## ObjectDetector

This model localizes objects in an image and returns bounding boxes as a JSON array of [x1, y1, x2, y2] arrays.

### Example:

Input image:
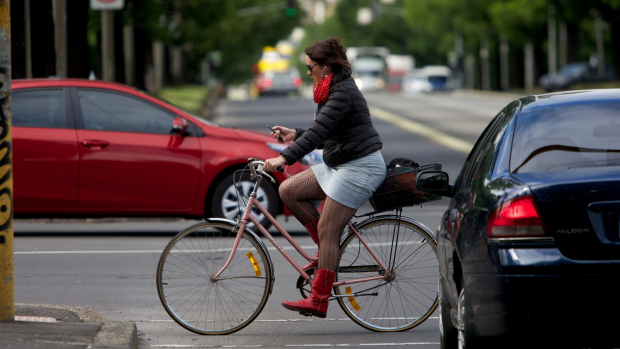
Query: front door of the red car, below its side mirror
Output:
[[72, 88, 201, 214]]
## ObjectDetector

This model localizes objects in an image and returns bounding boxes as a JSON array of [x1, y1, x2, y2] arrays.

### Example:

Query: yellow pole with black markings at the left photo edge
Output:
[[0, 0, 15, 321]]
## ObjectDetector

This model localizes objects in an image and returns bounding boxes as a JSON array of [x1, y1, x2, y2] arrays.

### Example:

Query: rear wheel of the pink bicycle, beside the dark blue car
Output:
[[334, 218, 439, 332]]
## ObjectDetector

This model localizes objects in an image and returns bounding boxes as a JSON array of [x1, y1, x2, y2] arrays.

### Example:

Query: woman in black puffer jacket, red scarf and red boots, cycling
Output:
[[264, 38, 386, 317]]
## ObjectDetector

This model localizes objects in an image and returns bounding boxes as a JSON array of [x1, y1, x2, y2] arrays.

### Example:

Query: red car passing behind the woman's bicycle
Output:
[[11, 79, 322, 228]]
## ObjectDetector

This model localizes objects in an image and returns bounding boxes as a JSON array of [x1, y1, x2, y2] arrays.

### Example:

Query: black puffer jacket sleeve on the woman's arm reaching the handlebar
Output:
[[280, 89, 351, 165]]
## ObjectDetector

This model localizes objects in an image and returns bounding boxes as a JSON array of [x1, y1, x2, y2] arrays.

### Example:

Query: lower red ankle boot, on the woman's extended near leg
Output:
[[282, 269, 336, 318]]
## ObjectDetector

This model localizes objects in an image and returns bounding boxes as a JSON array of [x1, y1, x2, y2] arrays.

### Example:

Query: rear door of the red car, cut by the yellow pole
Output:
[[11, 87, 79, 214]]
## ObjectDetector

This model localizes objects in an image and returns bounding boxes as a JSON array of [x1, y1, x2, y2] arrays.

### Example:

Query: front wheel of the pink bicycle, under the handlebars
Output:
[[157, 222, 272, 335]]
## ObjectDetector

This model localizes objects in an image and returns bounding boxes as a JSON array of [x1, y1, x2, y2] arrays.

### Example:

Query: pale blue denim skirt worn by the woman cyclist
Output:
[[311, 150, 386, 209]]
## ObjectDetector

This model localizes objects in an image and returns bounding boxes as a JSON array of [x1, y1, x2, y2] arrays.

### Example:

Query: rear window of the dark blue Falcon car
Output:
[[510, 103, 620, 173]]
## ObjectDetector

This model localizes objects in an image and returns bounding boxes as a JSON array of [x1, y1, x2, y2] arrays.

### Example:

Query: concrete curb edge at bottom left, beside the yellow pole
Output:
[[15, 303, 138, 349]]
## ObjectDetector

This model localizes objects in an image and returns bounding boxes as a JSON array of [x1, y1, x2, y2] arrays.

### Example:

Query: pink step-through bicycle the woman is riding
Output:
[[157, 159, 439, 335]]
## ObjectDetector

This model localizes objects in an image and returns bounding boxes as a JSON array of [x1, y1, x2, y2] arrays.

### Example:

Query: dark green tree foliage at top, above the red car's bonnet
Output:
[[125, 0, 302, 82]]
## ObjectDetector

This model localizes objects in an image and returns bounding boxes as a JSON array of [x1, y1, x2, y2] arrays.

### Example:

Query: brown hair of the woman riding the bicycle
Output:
[[305, 37, 351, 84]]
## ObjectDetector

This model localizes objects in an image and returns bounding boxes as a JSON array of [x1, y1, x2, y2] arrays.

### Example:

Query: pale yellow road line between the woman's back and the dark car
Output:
[[368, 107, 474, 154]]
